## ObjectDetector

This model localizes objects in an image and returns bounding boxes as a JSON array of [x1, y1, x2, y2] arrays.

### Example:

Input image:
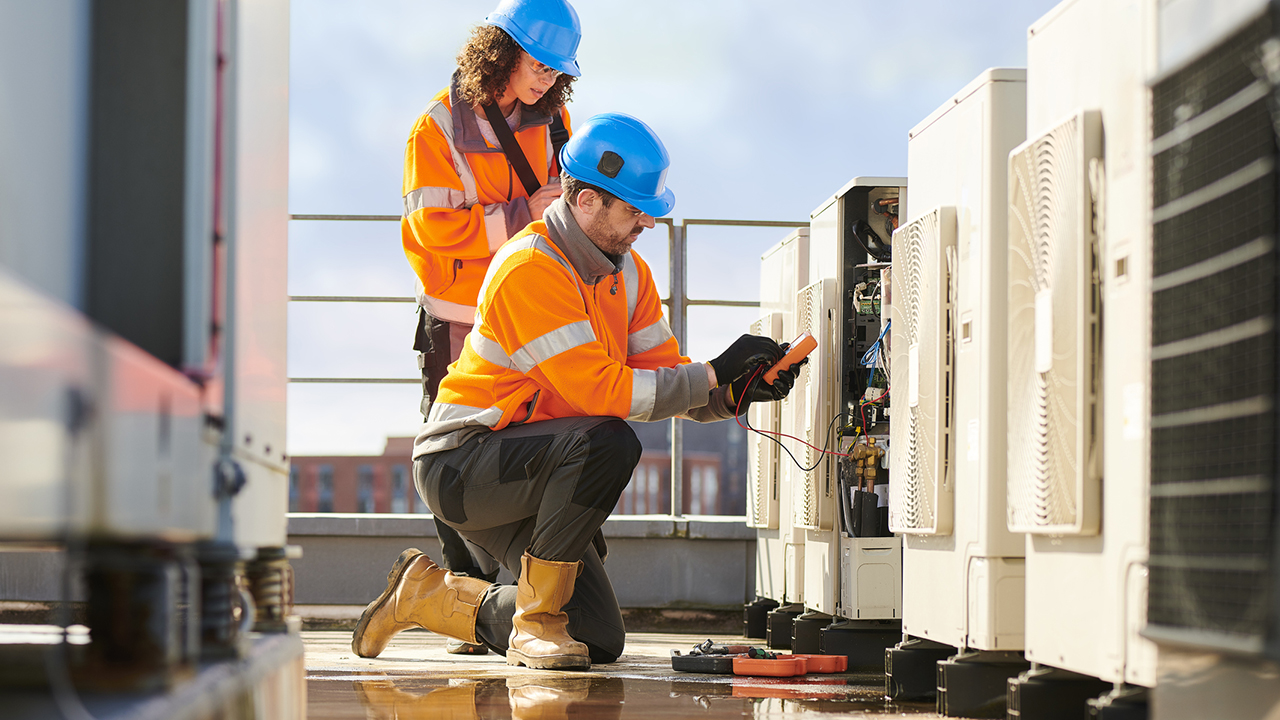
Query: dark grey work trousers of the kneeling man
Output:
[[413, 418, 641, 662]]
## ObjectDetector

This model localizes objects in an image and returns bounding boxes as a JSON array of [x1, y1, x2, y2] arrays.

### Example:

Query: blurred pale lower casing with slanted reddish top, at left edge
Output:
[[0, 269, 203, 541]]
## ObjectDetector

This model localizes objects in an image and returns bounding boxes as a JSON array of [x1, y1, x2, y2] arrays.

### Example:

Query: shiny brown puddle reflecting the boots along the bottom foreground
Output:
[[307, 673, 938, 720]]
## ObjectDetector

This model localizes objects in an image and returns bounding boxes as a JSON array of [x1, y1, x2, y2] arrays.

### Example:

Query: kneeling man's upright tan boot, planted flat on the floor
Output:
[[507, 552, 591, 670]]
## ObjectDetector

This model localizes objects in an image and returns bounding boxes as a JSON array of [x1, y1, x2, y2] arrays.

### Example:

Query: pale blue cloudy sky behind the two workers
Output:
[[288, 0, 1057, 455]]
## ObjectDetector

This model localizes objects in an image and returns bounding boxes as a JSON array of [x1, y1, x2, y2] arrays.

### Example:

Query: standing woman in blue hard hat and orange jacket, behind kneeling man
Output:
[[401, 0, 581, 652]]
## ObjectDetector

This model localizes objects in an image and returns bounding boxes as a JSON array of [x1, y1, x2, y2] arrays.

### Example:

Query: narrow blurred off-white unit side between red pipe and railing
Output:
[[224, 0, 289, 547]]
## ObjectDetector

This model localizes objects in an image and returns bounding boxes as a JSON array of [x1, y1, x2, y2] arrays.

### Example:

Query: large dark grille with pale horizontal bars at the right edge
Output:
[[1147, 9, 1280, 650]]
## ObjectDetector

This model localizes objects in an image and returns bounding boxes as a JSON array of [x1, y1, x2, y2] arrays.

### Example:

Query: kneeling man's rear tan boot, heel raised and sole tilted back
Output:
[[351, 548, 492, 657]]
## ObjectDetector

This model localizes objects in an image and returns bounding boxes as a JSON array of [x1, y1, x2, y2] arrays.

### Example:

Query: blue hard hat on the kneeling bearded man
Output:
[[559, 113, 676, 218]]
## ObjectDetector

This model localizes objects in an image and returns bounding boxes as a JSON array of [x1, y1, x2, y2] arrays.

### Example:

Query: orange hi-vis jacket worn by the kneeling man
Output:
[[413, 200, 733, 459]]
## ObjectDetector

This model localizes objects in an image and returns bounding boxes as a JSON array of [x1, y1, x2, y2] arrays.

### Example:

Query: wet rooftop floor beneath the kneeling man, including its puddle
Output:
[[302, 630, 941, 720]]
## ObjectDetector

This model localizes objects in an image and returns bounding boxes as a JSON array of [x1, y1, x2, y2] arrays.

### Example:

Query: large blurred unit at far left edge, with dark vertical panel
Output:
[[0, 3, 216, 542]]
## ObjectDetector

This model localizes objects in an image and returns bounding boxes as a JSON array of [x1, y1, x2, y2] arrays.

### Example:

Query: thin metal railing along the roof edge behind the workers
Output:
[[289, 214, 809, 519]]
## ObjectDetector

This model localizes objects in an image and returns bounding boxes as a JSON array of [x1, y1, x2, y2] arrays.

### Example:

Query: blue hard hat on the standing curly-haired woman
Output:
[[484, 0, 582, 77]]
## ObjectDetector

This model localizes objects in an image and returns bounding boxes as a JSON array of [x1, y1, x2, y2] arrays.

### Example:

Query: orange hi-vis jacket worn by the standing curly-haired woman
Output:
[[401, 73, 570, 324]]
